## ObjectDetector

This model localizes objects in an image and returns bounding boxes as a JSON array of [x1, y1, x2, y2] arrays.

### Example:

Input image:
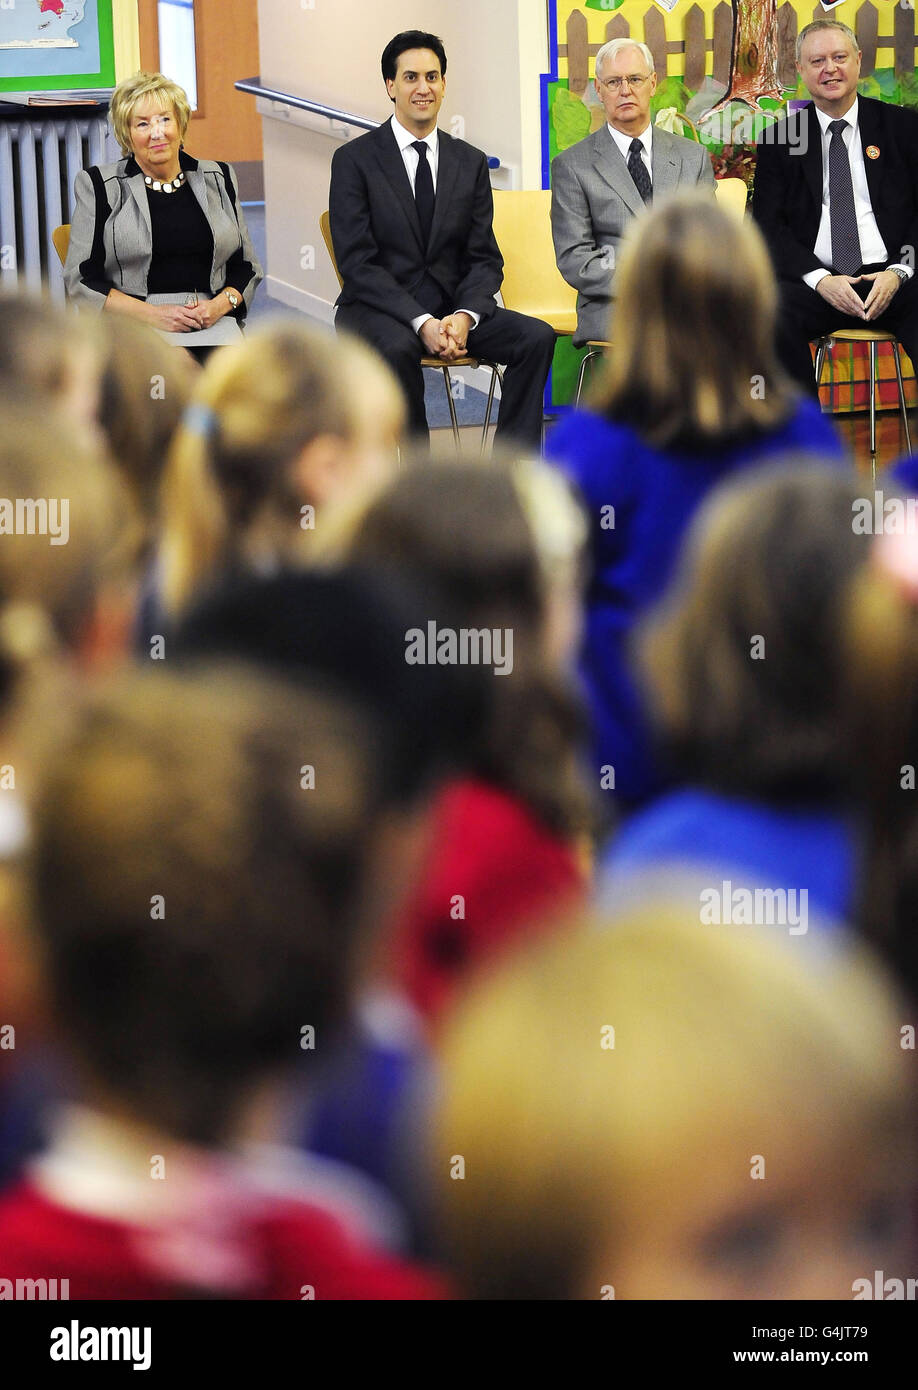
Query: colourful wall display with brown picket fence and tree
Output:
[[542, 0, 918, 409]]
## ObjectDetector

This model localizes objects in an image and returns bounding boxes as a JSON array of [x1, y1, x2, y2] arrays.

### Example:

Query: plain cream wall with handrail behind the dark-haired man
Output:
[[259, 0, 548, 322]]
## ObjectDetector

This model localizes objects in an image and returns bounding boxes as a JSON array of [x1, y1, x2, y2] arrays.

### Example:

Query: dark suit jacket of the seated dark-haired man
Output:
[[328, 121, 504, 324]]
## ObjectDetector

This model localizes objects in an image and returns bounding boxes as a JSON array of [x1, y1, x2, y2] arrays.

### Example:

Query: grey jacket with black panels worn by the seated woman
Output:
[[64, 150, 263, 318]]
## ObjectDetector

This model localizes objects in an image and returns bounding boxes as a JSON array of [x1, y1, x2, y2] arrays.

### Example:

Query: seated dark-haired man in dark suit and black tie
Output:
[[328, 29, 555, 449]]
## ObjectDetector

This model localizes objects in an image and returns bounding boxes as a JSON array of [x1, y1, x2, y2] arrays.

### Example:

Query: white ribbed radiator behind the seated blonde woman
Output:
[[0, 114, 120, 299]]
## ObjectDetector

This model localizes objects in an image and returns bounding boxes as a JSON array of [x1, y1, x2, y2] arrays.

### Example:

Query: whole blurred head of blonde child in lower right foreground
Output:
[[435, 905, 911, 1300]]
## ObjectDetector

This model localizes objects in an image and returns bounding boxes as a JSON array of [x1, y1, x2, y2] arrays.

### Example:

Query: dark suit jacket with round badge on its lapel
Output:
[[752, 96, 918, 279]]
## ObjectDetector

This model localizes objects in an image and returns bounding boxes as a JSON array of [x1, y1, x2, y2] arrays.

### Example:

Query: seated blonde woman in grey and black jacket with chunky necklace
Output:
[[64, 72, 263, 349]]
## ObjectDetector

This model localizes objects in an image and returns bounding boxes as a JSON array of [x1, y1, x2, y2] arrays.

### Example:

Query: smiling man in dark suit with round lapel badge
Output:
[[752, 19, 918, 393]]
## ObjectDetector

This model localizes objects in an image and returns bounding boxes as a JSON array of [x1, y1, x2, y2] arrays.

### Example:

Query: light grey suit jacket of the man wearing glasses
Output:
[[551, 125, 714, 346]]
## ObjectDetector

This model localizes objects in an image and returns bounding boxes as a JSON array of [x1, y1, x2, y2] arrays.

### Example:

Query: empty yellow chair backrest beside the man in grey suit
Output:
[[494, 188, 577, 318]]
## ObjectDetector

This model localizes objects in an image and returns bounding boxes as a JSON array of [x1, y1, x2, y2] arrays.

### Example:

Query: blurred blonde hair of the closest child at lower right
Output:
[[434, 904, 907, 1298]]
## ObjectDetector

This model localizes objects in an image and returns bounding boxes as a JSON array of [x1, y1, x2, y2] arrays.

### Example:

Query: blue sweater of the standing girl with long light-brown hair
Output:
[[545, 399, 847, 803]]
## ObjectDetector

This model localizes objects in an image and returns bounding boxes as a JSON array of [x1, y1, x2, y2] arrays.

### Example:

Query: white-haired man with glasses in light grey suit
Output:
[[551, 39, 714, 348]]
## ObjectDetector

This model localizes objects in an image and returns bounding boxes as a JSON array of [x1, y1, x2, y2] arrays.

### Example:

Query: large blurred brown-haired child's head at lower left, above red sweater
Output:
[[33, 667, 380, 1144]]
